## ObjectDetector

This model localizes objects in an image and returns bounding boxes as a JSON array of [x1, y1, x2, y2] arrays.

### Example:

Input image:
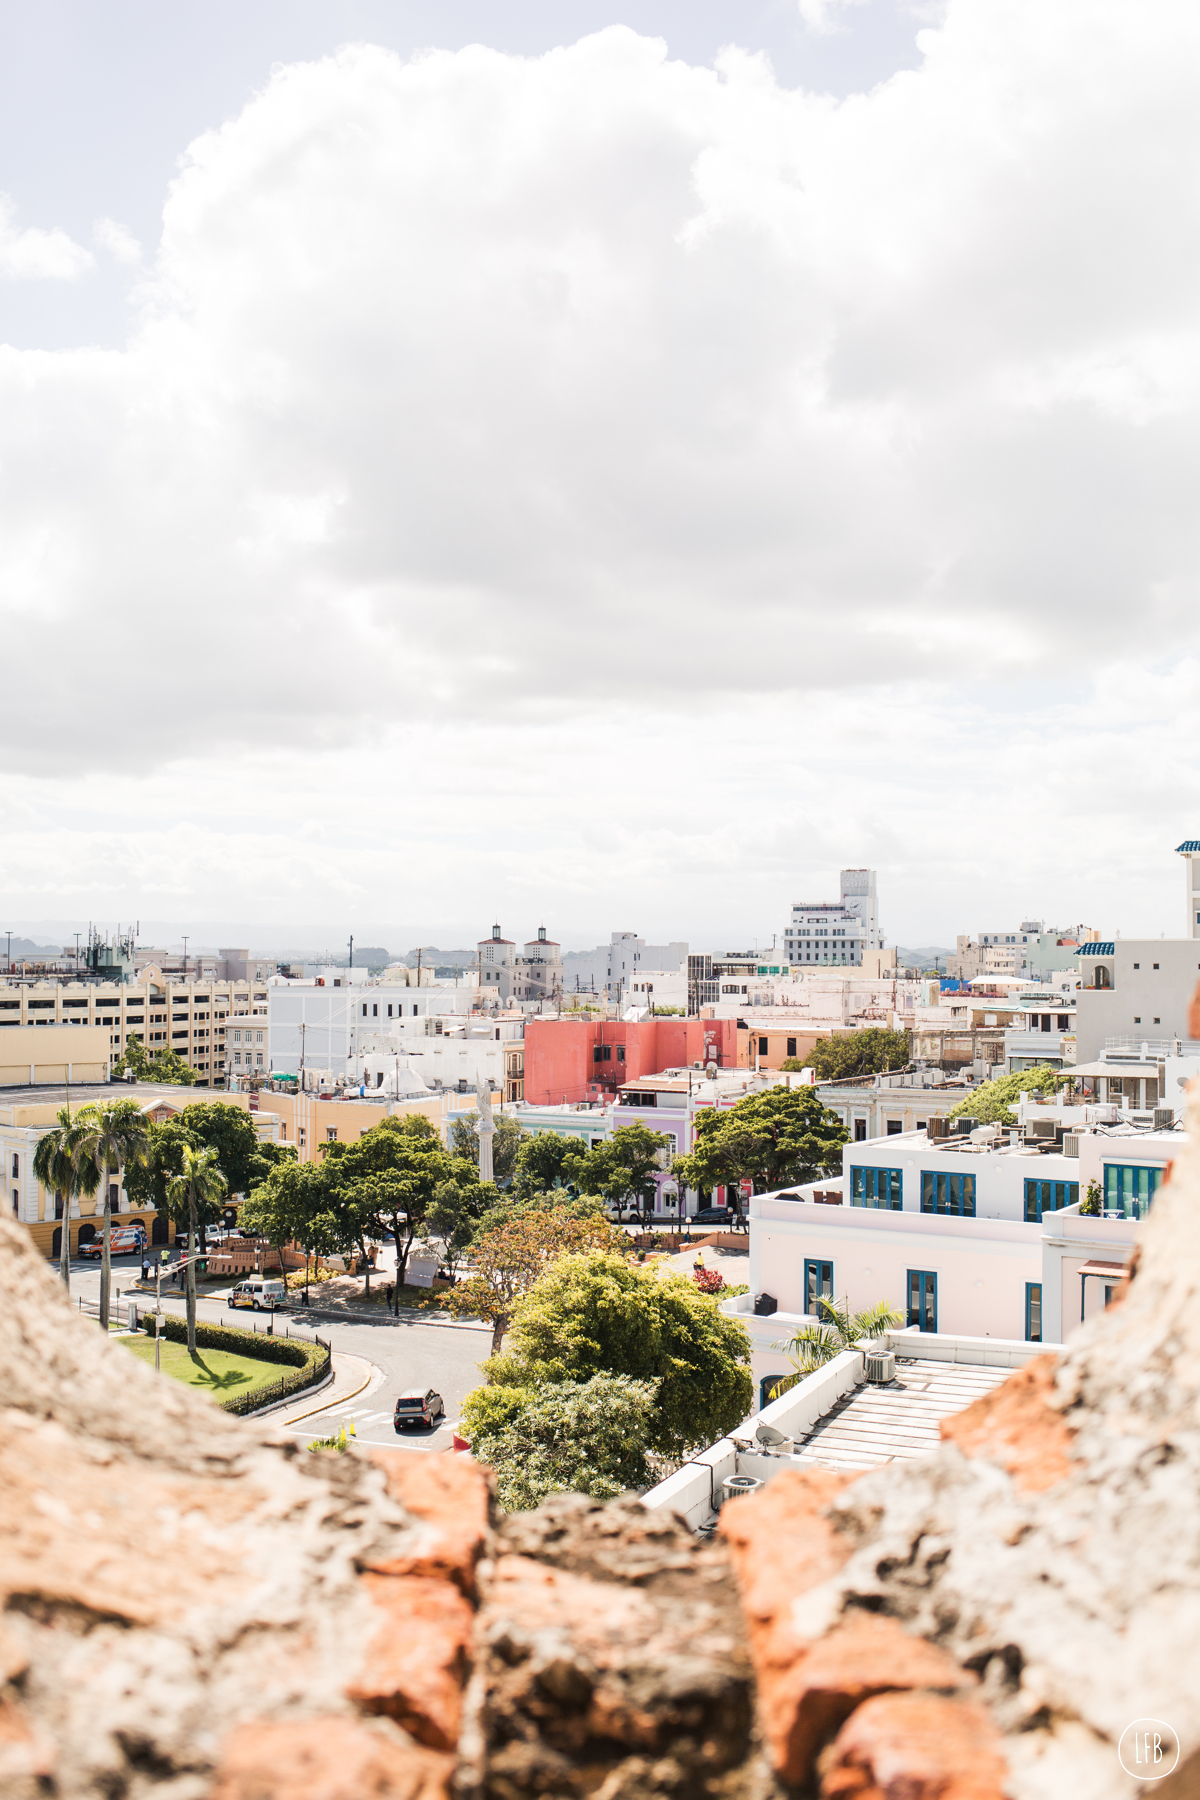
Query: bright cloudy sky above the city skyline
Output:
[[0, 0, 1200, 947]]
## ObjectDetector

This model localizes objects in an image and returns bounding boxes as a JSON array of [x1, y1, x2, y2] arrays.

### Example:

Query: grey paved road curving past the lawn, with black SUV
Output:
[[70, 1256, 491, 1451]]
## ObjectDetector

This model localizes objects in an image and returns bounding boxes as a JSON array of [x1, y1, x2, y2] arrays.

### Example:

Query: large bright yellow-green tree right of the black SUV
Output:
[[486, 1251, 754, 1454]]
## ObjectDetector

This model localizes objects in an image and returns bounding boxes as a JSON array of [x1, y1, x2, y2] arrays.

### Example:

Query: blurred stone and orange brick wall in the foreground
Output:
[[0, 1072, 1200, 1800]]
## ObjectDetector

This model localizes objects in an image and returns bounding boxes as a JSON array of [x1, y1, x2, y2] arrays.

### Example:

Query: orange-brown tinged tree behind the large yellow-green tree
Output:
[[446, 1204, 624, 1355]]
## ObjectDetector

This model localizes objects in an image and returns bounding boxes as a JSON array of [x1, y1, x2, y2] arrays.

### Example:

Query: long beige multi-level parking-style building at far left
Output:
[[0, 968, 266, 1087]]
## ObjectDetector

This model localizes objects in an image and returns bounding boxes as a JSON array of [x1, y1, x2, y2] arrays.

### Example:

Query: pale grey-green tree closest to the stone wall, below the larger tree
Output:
[[462, 1373, 655, 1512]]
